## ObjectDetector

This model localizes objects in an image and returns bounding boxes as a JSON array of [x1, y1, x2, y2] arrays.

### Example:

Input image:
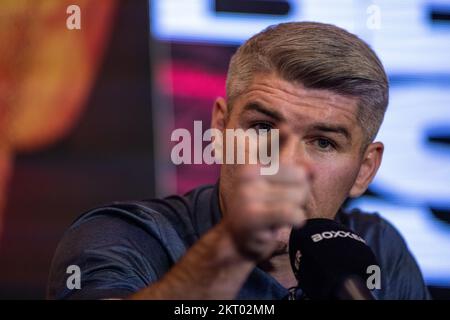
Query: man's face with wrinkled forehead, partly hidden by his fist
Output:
[[213, 74, 382, 218]]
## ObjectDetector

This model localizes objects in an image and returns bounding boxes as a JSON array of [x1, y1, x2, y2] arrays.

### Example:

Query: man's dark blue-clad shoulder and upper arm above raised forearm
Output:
[[48, 186, 220, 299]]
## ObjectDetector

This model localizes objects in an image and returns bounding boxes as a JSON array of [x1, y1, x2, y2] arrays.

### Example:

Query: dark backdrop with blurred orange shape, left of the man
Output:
[[0, 0, 154, 299]]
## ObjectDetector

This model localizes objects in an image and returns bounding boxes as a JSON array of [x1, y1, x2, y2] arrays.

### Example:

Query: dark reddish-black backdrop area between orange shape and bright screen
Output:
[[0, 0, 154, 299]]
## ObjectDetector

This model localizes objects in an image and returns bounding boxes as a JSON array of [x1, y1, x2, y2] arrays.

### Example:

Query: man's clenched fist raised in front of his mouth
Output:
[[222, 166, 309, 262]]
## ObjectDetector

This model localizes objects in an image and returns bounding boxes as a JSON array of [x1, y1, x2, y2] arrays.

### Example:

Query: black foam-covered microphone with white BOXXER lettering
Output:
[[289, 219, 378, 300]]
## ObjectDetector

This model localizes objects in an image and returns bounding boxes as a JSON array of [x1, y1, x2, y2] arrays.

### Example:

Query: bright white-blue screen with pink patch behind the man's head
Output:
[[150, 0, 450, 288]]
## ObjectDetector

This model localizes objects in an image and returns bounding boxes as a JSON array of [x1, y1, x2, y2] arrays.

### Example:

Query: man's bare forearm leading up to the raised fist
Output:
[[130, 223, 255, 299]]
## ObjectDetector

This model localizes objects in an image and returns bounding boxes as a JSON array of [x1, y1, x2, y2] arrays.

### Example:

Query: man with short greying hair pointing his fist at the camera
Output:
[[48, 22, 429, 299]]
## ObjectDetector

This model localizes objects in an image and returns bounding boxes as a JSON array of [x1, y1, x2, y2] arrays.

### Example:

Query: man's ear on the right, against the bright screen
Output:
[[349, 142, 384, 198]]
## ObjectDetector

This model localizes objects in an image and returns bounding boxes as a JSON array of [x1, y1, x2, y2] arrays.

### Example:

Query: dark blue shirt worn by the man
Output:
[[47, 184, 430, 299]]
